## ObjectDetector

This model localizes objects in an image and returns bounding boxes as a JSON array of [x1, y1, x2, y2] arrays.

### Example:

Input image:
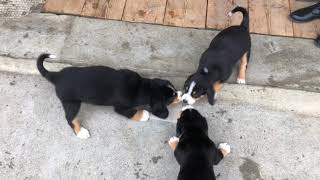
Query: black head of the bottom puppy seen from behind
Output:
[[176, 106, 208, 137]]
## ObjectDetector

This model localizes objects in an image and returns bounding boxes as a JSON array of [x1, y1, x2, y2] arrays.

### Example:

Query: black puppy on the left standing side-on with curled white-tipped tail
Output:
[[37, 54, 181, 139]]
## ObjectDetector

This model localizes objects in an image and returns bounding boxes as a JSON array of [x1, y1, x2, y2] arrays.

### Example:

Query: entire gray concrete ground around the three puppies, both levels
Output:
[[0, 13, 320, 180]]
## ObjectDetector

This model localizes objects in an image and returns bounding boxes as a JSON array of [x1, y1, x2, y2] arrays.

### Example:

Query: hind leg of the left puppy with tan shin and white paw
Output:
[[62, 101, 90, 139]]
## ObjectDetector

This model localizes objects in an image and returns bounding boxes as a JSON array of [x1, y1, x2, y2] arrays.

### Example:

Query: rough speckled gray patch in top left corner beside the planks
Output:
[[0, 0, 45, 19]]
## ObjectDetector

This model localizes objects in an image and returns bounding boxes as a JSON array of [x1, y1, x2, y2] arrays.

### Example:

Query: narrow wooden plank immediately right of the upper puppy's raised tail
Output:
[[249, 0, 270, 34]]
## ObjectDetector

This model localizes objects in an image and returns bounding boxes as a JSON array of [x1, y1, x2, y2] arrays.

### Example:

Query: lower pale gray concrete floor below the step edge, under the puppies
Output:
[[0, 72, 320, 180]]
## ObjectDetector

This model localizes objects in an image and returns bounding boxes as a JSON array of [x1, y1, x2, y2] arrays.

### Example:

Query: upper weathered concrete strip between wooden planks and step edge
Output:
[[0, 14, 320, 92]]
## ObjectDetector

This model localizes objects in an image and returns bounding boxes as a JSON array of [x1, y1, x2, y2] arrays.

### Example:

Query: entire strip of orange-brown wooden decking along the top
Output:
[[43, 0, 320, 38]]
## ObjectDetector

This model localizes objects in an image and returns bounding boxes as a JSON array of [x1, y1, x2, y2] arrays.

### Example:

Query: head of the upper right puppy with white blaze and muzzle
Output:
[[182, 68, 218, 105]]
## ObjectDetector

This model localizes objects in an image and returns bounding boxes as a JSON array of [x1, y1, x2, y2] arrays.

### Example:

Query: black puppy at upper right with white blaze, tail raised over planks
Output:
[[182, 7, 251, 105]]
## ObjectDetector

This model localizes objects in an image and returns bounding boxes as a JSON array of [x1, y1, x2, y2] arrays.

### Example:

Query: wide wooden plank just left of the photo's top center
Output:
[[122, 0, 167, 24]]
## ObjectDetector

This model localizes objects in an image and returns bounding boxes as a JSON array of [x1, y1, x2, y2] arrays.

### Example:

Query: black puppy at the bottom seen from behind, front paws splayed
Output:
[[169, 107, 230, 180]]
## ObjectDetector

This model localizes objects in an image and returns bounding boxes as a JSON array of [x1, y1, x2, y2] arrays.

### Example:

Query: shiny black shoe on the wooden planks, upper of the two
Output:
[[290, 3, 320, 22]]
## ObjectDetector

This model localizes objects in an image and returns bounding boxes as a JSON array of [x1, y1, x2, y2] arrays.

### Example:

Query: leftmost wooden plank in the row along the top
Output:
[[44, 0, 85, 15]]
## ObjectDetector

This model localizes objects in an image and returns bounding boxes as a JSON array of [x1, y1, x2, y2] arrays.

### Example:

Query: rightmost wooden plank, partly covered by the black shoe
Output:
[[290, 0, 320, 39]]
